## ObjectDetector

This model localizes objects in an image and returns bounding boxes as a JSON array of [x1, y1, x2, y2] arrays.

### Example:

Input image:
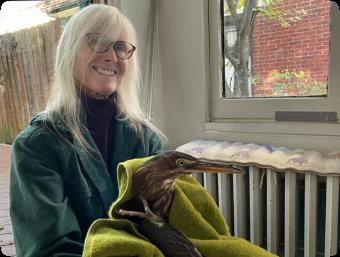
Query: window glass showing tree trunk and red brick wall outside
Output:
[[221, 0, 331, 98]]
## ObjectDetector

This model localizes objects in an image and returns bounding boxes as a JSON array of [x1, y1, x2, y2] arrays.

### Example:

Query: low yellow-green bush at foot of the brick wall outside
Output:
[[269, 70, 327, 96]]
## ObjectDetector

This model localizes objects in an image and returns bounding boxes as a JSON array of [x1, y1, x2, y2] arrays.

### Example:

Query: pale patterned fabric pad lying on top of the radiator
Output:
[[177, 140, 340, 176]]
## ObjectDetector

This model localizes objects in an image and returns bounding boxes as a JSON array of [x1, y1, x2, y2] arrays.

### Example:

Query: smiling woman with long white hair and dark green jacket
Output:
[[10, 5, 164, 257]]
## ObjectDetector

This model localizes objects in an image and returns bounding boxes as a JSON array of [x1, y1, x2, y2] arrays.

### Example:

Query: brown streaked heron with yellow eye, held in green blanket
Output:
[[118, 151, 244, 257]]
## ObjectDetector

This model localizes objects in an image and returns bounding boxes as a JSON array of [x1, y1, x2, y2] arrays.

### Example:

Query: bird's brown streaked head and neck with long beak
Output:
[[132, 151, 243, 220]]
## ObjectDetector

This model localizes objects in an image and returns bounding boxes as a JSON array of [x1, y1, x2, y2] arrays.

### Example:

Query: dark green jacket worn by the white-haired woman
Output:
[[10, 115, 162, 257]]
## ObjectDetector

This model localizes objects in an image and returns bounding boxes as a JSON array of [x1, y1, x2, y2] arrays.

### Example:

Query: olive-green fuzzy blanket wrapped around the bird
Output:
[[83, 157, 275, 257]]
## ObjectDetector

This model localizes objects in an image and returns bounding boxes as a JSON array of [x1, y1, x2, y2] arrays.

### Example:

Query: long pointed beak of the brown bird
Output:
[[186, 160, 245, 174]]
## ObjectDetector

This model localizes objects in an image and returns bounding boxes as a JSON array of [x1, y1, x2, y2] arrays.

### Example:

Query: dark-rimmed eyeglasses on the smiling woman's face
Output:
[[85, 33, 136, 60]]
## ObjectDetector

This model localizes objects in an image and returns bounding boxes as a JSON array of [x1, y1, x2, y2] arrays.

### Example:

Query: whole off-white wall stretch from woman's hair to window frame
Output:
[[120, 0, 208, 149]]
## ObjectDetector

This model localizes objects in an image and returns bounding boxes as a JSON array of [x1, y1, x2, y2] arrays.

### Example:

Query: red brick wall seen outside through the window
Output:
[[252, 0, 331, 96]]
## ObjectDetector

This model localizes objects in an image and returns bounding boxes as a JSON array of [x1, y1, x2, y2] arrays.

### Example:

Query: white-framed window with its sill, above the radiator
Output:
[[205, 0, 340, 148]]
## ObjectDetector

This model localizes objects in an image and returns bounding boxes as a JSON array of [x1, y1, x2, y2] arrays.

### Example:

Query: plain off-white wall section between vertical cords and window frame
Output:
[[159, 0, 208, 148]]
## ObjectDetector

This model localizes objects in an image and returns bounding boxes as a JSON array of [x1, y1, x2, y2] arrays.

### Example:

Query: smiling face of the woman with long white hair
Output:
[[74, 33, 128, 99]]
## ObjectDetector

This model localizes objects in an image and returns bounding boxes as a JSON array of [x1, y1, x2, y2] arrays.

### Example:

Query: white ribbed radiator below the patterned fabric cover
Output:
[[195, 166, 340, 257]]
